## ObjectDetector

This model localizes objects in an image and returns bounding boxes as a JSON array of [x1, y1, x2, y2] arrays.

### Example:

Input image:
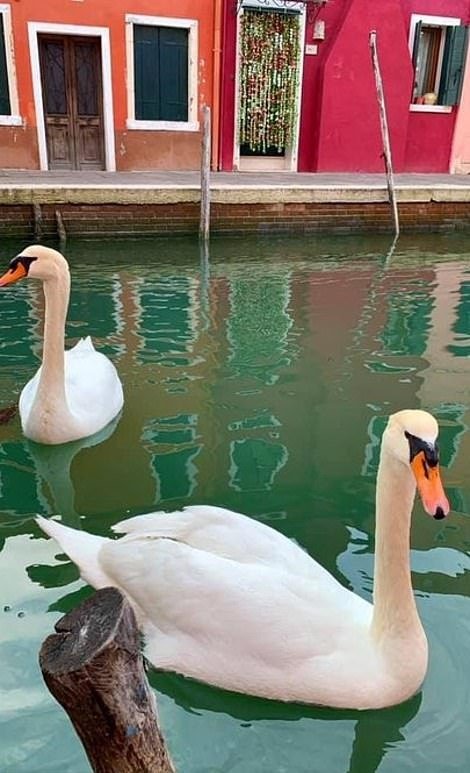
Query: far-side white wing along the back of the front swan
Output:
[[113, 505, 337, 584]]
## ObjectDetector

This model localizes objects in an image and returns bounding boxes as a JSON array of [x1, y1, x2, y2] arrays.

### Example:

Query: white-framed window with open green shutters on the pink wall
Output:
[[410, 14, 468, 111]]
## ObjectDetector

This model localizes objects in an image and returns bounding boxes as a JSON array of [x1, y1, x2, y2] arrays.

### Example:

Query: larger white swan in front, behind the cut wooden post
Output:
[[38, 411, 449, 709]]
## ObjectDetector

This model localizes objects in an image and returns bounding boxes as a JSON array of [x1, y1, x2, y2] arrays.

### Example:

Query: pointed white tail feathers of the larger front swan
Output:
[[36, 515, 111, 589]]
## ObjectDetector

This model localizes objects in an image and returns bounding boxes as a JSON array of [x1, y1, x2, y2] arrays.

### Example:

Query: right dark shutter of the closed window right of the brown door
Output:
[[159, 27, 188, 121]]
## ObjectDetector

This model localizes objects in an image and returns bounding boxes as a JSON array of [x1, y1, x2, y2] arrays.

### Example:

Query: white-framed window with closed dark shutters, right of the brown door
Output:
[[126, 15, 198, 131]]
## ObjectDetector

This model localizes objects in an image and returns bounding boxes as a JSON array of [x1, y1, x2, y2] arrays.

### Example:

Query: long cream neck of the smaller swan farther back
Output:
[[36, 269, 70, 411]]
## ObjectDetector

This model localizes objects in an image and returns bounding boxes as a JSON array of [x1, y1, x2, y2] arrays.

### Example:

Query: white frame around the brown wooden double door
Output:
[[28, 22, 116, 172]]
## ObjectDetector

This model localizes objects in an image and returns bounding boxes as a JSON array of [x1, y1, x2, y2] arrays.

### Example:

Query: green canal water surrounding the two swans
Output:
[[0, 235, 470, 773]]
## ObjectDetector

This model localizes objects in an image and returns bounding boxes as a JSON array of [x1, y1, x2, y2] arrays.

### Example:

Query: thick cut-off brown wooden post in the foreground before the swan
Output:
[[39, 588, 174, 773]]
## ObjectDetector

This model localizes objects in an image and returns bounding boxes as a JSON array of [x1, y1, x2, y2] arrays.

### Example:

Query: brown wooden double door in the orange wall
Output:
[[39, 35, 104, 169]]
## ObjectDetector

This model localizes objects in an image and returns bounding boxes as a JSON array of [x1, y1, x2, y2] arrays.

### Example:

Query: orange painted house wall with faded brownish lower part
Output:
[[0, 0, 214, 170]]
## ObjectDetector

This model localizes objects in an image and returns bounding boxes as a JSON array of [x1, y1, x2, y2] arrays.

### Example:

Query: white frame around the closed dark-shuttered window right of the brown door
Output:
[[125, 13, 199, 132]]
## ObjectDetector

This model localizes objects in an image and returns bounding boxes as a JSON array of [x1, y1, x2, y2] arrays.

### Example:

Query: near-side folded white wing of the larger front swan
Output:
[[99, 536, 370, 700]]
